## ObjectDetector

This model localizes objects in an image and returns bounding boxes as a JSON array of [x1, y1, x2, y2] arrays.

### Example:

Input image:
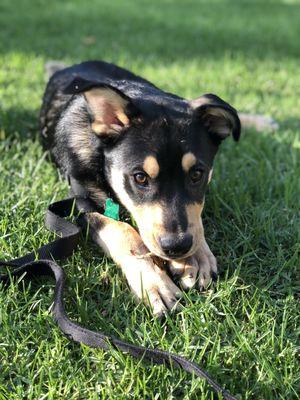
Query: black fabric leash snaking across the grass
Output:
[[0, 197, 236, 400]]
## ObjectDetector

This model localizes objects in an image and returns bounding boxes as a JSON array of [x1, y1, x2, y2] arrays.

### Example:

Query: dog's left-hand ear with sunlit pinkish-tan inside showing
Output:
[[64, 78, 137, 137]]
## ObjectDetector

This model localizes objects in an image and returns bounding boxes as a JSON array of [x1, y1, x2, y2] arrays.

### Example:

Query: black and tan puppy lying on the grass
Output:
[[40, 61, 240, 314]]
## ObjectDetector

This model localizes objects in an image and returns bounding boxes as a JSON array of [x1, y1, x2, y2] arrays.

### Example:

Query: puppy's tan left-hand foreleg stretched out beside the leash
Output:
[[86, 213, 181, 315]]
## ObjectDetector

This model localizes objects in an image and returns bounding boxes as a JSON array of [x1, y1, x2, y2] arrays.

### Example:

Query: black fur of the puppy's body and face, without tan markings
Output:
[[40, 61, 240, 256]]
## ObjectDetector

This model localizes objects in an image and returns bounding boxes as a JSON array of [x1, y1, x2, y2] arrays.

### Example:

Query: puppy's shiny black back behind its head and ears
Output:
[[40, 61, 186, 150]]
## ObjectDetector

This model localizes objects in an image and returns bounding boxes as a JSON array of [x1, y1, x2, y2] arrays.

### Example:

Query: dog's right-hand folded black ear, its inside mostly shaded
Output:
[[190, 94, 241, 143]]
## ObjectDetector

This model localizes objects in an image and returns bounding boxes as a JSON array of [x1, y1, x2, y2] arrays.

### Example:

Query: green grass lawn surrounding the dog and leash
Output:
[[0, 0, 300, 400]]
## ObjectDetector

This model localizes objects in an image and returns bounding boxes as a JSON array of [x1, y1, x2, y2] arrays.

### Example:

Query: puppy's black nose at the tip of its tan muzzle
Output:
[[158, 233, 193, 257]]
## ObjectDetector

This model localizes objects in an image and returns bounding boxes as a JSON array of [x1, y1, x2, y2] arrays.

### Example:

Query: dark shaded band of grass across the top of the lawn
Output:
[[0, 0, 300, 62]]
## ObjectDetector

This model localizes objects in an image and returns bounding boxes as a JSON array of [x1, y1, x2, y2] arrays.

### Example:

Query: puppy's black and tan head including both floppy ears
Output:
[[65, 77, 240, 260]]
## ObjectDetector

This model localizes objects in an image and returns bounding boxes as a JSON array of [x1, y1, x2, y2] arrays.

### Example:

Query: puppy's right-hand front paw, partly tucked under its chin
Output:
[[169, 240, 218, 290]]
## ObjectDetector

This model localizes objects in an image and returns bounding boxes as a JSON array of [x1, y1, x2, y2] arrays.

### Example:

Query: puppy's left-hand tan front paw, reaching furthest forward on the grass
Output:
[[122, 257, 182, 316]]
